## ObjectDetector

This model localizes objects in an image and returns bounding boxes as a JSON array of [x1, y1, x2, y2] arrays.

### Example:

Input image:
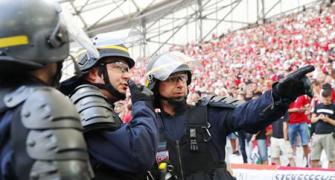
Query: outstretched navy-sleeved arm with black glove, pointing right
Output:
[[222, 66, 314, 133]]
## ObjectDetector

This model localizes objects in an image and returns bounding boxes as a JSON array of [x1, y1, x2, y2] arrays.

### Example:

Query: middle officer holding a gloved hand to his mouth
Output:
[[61, 44, 159, 180]]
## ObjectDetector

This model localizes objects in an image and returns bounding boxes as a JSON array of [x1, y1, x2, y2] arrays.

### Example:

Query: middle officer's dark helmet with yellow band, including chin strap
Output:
[[78, 44, 135, 100]]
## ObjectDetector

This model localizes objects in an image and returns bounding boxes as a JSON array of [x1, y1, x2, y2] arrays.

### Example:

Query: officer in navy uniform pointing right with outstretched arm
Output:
[[147, 52, 314, 180]]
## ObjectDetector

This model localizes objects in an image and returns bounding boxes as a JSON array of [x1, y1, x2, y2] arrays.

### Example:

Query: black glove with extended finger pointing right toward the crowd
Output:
[[272, 65, 315, 104]]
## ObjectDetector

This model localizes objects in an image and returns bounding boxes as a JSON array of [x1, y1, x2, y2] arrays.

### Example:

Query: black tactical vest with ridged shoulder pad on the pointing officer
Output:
[[155, 96, 243, 180]]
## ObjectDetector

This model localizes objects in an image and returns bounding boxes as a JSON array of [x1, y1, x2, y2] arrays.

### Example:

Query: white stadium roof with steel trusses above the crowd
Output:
[[59, 0, 322, 57]]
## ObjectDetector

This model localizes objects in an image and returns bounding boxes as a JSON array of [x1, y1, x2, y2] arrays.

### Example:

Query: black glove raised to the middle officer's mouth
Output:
[[128, 79, 154, 107]]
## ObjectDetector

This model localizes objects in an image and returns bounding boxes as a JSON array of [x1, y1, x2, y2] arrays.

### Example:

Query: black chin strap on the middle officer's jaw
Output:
[[95, 64, 126, 101]]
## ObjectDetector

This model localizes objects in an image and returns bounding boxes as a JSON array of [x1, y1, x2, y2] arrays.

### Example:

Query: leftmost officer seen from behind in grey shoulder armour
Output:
[[0, 0, 93, 180]]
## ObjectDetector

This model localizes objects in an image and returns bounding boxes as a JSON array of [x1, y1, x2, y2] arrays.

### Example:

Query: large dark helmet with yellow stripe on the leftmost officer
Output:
[[0, 0, 69, 72]]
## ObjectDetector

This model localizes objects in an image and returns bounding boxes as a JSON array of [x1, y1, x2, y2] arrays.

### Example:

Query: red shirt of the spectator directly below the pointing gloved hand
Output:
[[289, 95, 310, 124]]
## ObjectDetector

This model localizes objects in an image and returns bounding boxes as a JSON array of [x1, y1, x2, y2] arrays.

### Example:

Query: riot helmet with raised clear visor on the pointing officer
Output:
[[146, 52, 192, 91]]
